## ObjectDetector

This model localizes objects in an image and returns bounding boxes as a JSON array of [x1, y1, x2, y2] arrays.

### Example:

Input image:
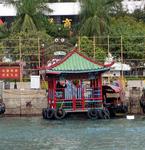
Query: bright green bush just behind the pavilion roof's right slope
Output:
[[80, 36, 106, 61]]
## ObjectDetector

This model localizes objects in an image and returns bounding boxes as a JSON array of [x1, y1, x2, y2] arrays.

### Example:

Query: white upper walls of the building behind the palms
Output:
[[0, 0, 145, 17]]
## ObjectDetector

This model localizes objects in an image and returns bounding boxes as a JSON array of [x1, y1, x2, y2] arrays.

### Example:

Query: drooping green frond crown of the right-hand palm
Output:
[[80, 0, 109, 36]]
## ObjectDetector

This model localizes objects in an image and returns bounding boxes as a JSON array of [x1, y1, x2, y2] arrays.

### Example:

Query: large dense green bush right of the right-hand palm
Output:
[[110, 16, 145, 59]]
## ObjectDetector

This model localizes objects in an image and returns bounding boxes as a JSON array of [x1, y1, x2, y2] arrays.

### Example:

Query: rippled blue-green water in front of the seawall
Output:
[[0, 117, 145, 150]]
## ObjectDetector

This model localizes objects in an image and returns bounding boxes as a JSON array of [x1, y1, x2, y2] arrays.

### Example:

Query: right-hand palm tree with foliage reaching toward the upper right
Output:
[[80, 0, 126, 36]]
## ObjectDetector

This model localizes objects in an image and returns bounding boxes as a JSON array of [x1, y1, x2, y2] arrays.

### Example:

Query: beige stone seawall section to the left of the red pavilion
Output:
[[3, 83, 47, 115]]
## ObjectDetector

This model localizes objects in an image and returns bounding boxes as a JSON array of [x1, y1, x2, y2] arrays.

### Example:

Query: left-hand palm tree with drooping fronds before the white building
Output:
[[5, 0, 50, 32]]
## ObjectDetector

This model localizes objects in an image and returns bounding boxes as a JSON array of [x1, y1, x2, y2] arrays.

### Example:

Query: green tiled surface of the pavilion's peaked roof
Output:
[[49, 52, 108, 72]]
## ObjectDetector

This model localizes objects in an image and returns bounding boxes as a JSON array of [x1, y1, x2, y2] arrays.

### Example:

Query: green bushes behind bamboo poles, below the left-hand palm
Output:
[[3, 31, 52, 61]]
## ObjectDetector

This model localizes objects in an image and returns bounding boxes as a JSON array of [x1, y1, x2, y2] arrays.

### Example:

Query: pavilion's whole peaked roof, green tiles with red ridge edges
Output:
[[43, 49, 109, 74]]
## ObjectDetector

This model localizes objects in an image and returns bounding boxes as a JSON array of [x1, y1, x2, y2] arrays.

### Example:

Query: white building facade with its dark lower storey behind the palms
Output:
[[0, 0, 145, 23]]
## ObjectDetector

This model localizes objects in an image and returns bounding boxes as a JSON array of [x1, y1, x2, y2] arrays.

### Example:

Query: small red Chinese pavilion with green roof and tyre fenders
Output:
[[41, 49, 110, 119]]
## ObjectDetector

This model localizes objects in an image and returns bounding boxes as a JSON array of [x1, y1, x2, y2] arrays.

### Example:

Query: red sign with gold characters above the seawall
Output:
[[0, 67, 20, 79]]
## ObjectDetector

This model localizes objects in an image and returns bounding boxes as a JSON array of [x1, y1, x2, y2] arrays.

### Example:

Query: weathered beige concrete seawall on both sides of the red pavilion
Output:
[[2, 80, 145, 115]]
